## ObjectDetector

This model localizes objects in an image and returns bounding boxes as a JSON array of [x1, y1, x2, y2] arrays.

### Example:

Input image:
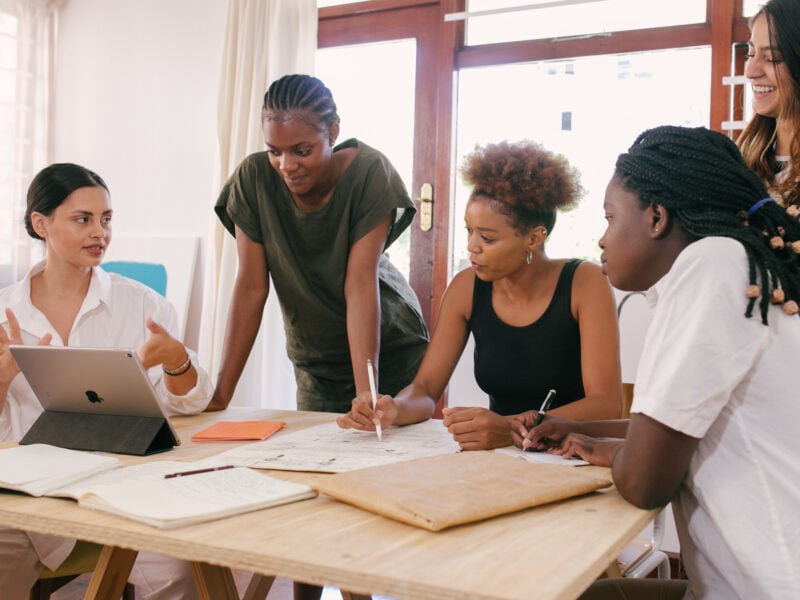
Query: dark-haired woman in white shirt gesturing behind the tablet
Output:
[[0, 163, 213, 600]]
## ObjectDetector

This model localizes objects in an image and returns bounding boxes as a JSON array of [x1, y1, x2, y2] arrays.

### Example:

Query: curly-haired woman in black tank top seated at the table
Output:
[[338, 141, 622, 450]]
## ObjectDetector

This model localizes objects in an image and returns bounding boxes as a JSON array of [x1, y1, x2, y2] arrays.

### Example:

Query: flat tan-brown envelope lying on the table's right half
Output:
[[314, 452, 612, 531]]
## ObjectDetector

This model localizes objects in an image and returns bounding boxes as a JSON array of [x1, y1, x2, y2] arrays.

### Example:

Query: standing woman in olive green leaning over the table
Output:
[[209, 74, 428, 412]]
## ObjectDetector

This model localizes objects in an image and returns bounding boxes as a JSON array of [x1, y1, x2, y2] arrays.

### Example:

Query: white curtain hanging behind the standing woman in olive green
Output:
[[199, 0, 317, 409]]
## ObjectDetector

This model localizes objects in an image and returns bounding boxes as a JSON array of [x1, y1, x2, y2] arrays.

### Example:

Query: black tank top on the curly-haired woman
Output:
[[468, 259, 586, 415]]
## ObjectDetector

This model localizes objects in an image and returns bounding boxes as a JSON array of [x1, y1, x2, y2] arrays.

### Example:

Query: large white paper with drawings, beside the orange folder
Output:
[[204, 419, 459, 473]]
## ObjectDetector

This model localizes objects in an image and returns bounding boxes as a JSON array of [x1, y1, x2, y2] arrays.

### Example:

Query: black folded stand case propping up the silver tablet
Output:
[[20, 410, 178, 456]]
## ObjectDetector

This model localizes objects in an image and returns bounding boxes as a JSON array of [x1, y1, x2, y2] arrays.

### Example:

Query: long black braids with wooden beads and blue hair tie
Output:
[[615, 126, 800, 325]]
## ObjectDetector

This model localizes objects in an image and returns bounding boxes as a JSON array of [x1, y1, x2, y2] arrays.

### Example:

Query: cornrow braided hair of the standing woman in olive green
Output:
[[261, 74, 339, 131]]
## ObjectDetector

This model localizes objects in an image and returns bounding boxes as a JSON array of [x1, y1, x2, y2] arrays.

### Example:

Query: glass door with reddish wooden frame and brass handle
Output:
[[316, 4, 450, 324]]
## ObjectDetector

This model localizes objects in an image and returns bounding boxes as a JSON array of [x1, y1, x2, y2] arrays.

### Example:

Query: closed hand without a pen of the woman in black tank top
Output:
[[442, 407, 512, 450]]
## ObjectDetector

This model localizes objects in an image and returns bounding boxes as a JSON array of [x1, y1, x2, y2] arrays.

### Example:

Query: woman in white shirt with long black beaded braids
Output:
[[523, 127, 800, 600]]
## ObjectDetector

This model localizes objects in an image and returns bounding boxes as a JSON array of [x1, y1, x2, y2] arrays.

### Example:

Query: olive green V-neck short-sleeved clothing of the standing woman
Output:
[[215, 139, 428, 405]]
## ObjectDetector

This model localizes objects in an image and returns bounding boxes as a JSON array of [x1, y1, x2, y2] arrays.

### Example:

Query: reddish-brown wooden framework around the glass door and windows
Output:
[[318, 0, 750, 325]]
